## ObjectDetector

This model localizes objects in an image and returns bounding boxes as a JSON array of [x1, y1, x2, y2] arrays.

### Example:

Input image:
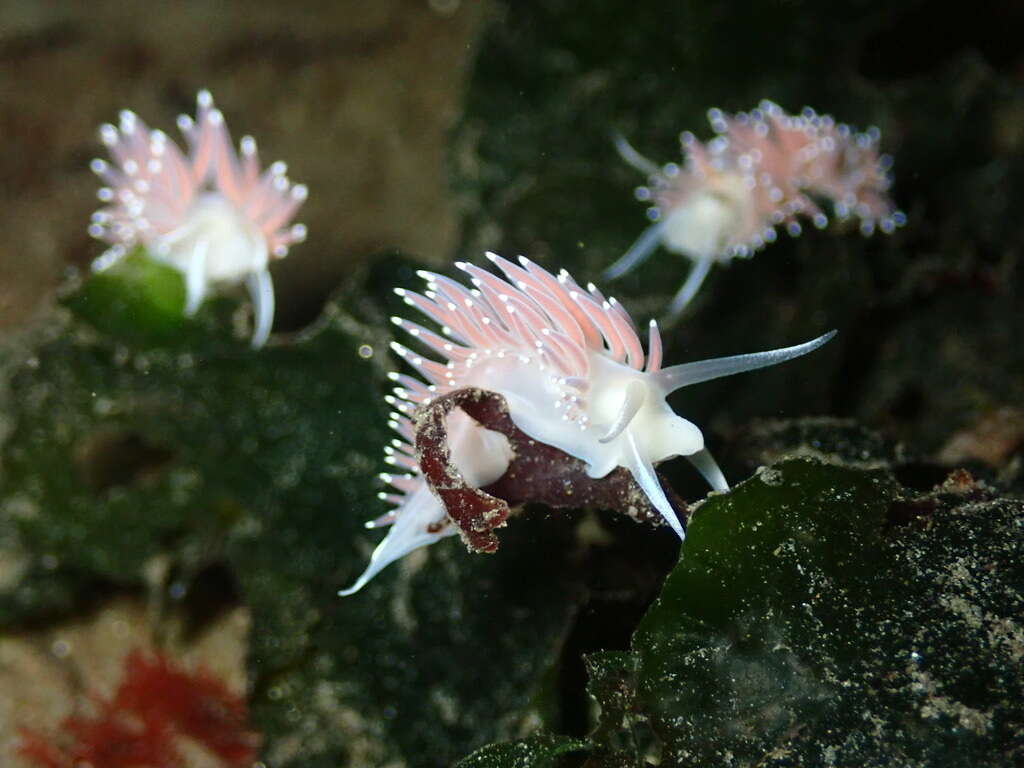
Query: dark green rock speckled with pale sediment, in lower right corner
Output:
[[577, 460, 1024, 766]]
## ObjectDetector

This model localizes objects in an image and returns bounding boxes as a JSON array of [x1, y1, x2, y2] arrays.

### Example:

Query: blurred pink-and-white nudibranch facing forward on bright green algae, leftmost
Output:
[[89, 90, 306, 347]]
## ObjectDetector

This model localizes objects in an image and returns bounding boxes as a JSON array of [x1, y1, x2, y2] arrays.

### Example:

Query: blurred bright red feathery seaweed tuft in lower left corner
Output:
[[18, 651, 259, 768]]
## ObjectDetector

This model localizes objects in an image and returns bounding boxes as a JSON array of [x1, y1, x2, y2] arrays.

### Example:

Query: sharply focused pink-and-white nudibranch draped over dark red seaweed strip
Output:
[[340, 253, 835, 595]]
